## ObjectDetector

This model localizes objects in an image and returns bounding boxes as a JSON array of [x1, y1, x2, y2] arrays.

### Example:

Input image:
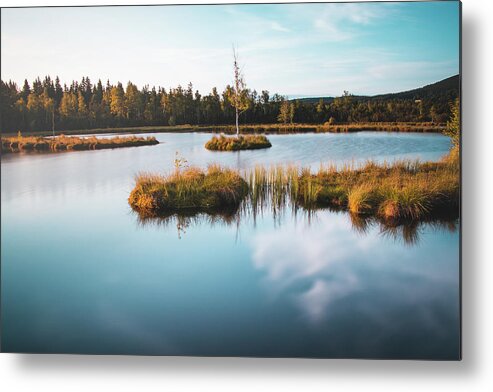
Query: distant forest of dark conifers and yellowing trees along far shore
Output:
[[0, 75, 459, 132]]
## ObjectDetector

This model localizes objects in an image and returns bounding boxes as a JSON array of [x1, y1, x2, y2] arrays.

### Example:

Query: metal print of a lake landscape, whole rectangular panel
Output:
[[1, 1, 461, 360]]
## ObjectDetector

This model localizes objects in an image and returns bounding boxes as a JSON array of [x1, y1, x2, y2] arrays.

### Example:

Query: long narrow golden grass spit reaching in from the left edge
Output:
[[2, 135, 159, 153]]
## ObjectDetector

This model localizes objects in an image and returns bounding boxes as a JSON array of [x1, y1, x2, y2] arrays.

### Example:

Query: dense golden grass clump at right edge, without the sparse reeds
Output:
[[297, 155, 460, 222]]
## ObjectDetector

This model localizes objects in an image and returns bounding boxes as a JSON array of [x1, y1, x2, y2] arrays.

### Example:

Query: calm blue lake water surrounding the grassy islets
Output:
[[1, 132, 460, 359]]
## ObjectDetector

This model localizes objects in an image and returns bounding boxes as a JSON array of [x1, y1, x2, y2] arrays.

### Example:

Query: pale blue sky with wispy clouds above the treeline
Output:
[[1, 1, 459, 98]]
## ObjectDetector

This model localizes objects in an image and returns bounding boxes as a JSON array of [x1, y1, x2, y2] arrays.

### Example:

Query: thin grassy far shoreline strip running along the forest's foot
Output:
[[4, 122, 445, 136]]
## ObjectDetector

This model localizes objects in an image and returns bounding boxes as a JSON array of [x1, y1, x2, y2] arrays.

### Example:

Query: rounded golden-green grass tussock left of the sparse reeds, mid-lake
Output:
[[128, 165, 248, 216]]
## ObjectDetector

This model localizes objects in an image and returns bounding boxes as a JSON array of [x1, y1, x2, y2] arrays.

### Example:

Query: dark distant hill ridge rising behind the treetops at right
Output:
[[291, 75, 460, 103]]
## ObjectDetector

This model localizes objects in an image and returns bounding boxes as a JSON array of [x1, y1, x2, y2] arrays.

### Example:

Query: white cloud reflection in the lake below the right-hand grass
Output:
[[251, 213, 458, 323]]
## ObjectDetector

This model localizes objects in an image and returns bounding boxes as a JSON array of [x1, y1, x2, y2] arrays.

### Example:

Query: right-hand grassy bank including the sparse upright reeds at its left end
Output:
[[249, 155, 460, 222]]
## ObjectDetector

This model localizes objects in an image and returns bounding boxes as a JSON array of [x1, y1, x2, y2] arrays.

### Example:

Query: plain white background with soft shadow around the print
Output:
[[0, 0, 493, 392]]
